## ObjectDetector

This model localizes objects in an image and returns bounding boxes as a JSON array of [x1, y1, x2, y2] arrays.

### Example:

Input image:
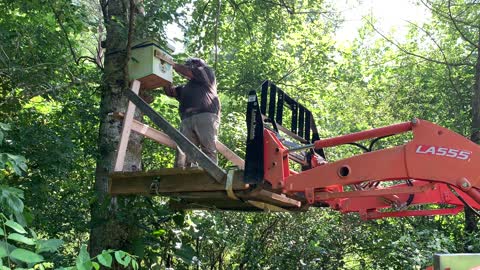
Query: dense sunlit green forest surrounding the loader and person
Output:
[[0, 0, 480, 269]]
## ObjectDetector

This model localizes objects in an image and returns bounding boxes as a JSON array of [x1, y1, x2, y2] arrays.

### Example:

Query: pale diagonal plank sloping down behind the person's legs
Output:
[[113, 112, 245, 169]]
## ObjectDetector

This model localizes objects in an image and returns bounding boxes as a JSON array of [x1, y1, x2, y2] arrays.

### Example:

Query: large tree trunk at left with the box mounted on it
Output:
[[89, 0, 142, 256]]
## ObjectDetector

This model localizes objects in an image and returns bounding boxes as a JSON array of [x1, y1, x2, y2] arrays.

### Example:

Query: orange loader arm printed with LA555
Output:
[[264, 119, 480, 219]]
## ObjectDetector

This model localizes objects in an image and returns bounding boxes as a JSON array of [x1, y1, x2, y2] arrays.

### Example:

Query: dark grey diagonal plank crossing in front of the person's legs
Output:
[[125, 90, 227, 183]]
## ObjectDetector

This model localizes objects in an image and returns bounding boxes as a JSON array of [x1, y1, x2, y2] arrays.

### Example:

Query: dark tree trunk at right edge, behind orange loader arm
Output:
[[465, 32, 480, 240]]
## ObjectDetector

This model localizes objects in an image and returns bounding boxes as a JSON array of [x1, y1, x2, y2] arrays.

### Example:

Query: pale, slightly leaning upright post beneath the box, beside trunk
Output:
[[113, 80, 140, 172]]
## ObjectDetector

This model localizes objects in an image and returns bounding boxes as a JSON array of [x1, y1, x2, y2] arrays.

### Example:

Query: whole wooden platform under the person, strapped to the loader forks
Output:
[[109, 168, 306, 211]]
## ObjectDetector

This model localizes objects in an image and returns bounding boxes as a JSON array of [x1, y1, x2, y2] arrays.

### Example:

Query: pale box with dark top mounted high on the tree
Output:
[[128, 40, 173, 89]]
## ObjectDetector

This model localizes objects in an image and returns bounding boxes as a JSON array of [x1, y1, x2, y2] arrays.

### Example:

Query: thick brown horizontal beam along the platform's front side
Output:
[[109, 168, 249, 197]]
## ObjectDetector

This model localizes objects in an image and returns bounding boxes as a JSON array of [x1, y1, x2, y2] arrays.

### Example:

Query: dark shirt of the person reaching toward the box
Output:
[[175, 66, 220, 119]]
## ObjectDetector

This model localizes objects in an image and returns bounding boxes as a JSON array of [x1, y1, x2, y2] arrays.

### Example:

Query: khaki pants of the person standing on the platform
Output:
[[175, 113, 220, 167]]
